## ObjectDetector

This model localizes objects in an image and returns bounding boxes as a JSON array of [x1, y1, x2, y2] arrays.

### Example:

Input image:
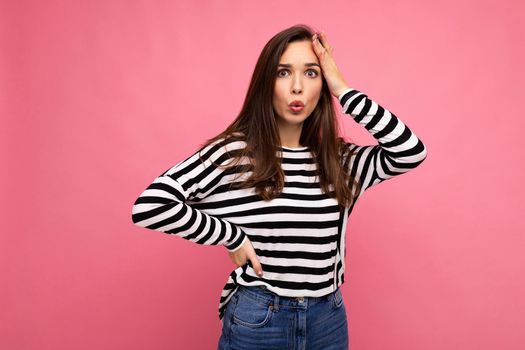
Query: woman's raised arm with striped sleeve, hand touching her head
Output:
[[312, 33, 427, 192]]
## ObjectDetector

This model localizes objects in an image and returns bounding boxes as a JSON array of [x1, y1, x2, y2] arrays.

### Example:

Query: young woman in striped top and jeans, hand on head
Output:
[[132, 25, 427, 350]]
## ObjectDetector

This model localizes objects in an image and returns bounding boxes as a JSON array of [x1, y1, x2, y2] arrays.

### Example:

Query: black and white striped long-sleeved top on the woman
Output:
[[132, 88, 427, 322]]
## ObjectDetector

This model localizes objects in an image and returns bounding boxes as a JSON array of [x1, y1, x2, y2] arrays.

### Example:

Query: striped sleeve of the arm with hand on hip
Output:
[[132, 140, 247, 252]]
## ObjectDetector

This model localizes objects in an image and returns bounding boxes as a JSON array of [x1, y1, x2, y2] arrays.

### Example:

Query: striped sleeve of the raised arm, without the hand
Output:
[[338, 88, 427, 192]]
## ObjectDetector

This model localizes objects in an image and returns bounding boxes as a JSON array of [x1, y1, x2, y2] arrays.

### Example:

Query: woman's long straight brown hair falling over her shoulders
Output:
[[199, 24, 360, 210]]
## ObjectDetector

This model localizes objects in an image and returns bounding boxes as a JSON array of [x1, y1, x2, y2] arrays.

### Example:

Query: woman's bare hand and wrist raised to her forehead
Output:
[[312, 32, 349, 97]]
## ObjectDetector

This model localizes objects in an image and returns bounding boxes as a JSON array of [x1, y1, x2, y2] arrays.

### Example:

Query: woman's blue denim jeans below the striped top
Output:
[[218, 285, 348, 350]]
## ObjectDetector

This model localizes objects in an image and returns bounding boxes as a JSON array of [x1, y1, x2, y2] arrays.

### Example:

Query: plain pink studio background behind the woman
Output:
[[0, 0, 525, 350]]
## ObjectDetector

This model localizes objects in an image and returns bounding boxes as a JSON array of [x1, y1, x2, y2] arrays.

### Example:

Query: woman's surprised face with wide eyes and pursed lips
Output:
[[273, 40, 323, 126]]
